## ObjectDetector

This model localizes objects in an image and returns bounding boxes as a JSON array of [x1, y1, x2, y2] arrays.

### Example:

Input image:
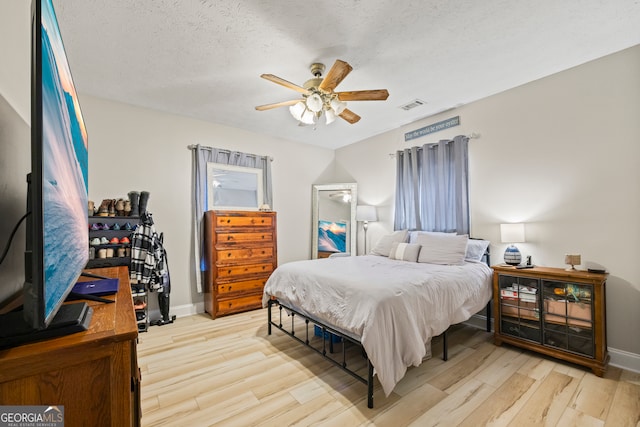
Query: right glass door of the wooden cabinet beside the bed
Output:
[[542, 280, 595, 357]]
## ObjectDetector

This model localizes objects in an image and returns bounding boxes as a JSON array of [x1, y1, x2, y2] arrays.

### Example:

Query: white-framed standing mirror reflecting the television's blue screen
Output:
[[311, 183, 358, 259]]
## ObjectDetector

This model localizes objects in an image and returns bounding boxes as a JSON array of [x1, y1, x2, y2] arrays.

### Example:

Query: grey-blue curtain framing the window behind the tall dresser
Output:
[[190, 144, 273, 292]]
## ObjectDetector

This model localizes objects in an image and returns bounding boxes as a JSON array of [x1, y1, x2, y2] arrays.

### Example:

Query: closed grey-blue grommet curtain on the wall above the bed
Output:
[[394, 135, 469, 234]]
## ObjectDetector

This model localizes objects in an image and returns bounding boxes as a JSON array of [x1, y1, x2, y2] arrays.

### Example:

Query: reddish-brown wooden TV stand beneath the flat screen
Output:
[[0, 267, 140, 426]]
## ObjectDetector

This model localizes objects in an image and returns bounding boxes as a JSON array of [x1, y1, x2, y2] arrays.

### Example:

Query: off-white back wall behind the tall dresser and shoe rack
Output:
[[79, 94, 334, 314]]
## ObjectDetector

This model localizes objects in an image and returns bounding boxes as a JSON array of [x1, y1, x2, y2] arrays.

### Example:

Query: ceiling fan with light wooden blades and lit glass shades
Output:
[[256, 59, 389, 125]]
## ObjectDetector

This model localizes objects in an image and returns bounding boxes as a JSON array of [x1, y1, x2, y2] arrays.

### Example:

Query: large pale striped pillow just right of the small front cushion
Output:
[[417, 234, 469, 265]]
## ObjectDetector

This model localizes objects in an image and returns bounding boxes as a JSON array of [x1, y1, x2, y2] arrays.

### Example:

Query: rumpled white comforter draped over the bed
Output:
[[262, 255, 492, 396]]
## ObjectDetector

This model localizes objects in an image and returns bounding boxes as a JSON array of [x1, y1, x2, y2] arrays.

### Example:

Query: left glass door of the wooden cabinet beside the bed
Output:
[[498, 275, 542, 343]]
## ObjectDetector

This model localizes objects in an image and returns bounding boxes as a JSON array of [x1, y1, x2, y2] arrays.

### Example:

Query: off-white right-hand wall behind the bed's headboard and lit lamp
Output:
[[336, 46, 640, 370]]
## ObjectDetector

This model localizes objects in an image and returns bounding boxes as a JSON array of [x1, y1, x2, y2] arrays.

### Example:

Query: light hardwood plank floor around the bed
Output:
[[138, 309, 640, 427]]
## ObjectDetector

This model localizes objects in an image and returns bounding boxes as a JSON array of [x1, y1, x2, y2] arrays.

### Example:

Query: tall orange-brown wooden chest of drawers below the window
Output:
[[204, 211, 278, 318]]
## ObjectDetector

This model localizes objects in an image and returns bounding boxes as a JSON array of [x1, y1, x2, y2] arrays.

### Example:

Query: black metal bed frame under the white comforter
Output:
[[267, 248, 491, 408]]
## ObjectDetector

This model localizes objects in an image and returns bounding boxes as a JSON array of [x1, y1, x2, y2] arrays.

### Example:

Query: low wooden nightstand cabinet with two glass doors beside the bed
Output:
[[492, 266, 609, 377]]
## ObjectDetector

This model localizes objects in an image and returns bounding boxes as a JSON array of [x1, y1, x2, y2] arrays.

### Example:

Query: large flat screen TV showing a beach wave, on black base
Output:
[[0, 0, 91, 347]]
